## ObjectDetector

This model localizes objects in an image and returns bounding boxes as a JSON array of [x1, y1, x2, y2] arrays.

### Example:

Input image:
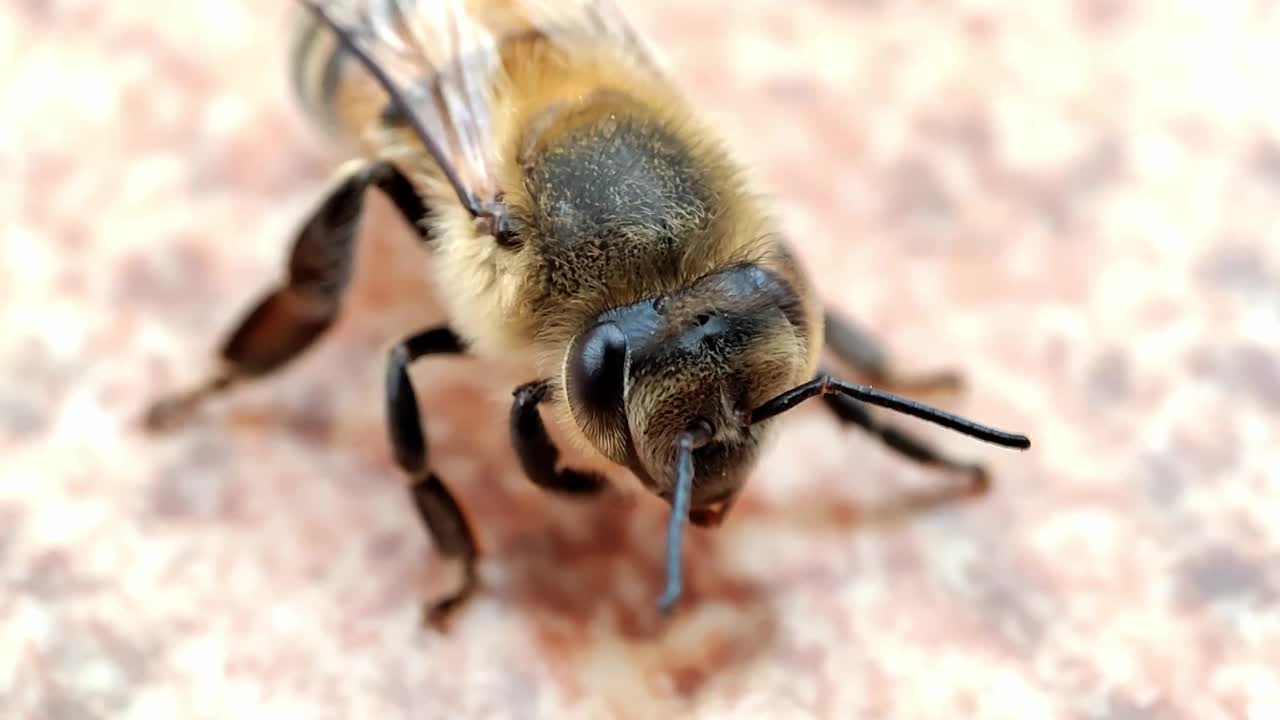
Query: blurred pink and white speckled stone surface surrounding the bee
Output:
[[0, 0, 1280, 720]]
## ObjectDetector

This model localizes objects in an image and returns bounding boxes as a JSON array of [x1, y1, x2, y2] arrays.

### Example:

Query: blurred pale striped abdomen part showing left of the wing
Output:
[[289, 9, 355, 133]]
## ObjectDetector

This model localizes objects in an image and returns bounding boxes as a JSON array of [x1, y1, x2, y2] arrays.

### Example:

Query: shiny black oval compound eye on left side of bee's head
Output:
[[566, 323, 627, 416]]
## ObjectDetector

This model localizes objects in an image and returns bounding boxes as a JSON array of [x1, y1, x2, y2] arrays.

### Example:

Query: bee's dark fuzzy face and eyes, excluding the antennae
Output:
[[564, 265, 806, 507]]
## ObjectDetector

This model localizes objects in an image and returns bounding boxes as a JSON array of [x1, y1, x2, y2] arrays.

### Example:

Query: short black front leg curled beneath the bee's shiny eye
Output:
[[511, 380, 607, 495]]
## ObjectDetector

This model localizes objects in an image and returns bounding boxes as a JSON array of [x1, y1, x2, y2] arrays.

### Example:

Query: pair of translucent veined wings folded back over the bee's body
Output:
[[302, 0, 658, 214]]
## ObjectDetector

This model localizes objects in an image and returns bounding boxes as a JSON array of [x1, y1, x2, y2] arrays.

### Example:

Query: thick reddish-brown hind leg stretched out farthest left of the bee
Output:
[[145, 163, 426, 430]]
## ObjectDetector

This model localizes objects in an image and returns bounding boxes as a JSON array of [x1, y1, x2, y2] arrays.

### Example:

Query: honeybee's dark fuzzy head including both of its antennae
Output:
[[563, 264, 1030, 610]]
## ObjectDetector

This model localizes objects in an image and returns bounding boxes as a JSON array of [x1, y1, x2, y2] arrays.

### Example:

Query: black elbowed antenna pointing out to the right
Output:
[[744, 375, 1032, 450]]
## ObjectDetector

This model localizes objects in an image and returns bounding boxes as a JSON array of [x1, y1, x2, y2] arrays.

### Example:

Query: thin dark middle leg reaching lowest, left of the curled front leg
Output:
[[387, 327, 477, 629]]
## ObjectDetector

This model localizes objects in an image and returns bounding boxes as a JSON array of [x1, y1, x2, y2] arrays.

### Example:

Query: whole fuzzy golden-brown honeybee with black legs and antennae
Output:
[[146, 0, 1030, 625]]
